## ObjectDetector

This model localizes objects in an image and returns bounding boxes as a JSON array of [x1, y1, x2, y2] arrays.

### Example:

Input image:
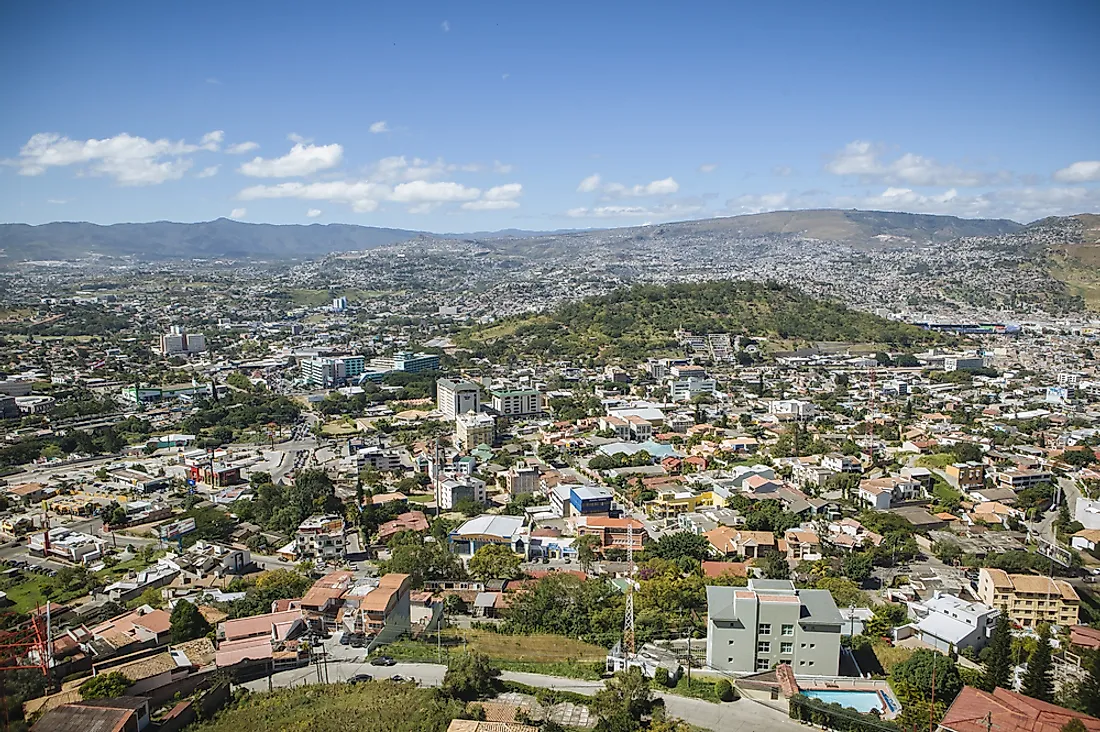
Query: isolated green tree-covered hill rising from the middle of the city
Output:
[[459, 281, 936, 361]]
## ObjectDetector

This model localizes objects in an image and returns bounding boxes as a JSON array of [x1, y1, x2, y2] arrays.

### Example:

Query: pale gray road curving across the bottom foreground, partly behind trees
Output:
[[244, 662, 803, 732]]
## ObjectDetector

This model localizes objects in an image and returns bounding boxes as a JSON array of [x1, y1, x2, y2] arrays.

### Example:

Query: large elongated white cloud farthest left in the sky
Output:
[[15, 130, 224, 186]]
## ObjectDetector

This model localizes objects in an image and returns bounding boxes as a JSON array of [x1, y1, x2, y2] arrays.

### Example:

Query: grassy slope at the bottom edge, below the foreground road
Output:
[[188, 680, 465, 732]]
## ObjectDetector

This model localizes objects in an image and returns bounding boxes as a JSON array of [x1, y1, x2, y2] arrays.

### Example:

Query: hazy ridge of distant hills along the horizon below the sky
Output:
[[0, 209, 1022, 262]]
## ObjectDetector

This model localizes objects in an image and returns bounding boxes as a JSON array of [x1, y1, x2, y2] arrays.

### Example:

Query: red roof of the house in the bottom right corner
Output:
[[937, 686, 1100, 732]]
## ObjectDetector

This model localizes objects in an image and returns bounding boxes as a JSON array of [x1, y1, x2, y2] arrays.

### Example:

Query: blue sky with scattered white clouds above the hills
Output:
[[0, 0, 1100, 232]]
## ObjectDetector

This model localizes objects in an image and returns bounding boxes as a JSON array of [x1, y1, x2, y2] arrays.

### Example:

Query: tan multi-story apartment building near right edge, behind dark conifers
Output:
[[978, 567, 1081, 626]]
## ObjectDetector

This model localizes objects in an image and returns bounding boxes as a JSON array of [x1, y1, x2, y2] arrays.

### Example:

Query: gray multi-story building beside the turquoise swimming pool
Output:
[[706, 579, 844, 676]]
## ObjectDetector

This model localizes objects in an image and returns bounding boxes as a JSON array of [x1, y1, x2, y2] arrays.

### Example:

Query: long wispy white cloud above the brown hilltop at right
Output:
[[825, 140, 1011, 188]]
